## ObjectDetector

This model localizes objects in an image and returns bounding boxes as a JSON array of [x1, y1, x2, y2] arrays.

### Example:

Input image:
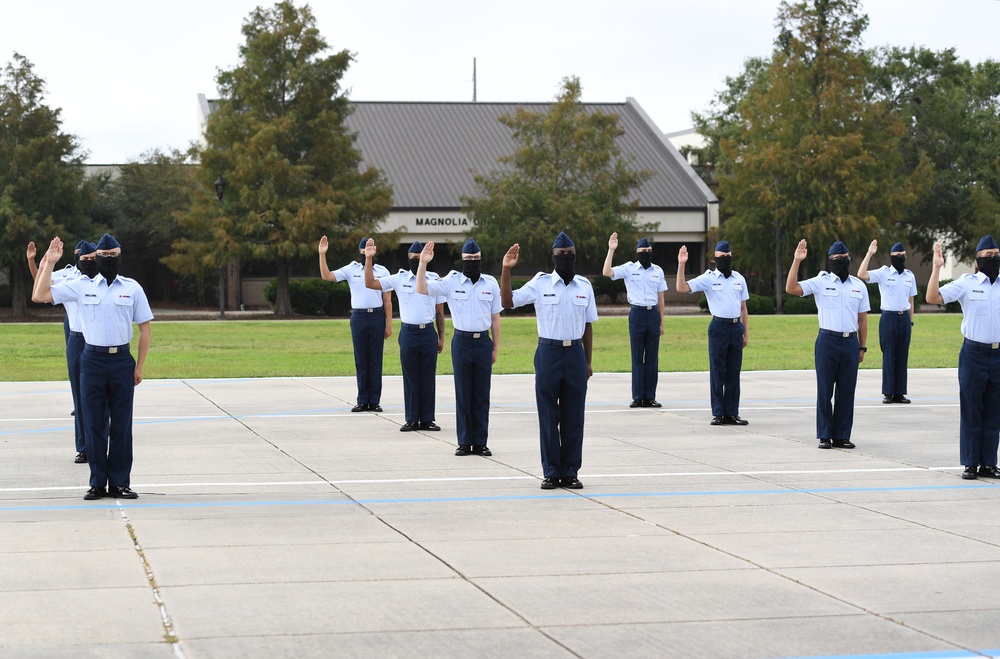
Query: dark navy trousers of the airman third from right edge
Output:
[[816, 330, 861, 439]]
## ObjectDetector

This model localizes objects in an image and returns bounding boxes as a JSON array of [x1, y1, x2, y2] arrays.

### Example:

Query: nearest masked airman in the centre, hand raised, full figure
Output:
[[500, 232, 597, 490]]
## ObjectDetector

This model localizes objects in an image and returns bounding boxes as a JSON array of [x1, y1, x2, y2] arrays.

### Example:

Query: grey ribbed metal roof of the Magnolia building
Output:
[[346, 98, 718, 209]]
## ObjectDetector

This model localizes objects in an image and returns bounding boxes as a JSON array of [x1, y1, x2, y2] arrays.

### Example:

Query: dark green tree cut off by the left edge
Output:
[[0, 53, 92, 316]]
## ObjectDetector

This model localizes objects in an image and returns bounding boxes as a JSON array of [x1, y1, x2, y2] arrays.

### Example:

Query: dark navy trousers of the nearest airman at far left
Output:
[[77, 346, 135, 487]]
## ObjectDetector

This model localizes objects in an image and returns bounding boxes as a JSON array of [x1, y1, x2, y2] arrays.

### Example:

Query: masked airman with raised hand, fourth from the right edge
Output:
[[674, 240, 750, 426]]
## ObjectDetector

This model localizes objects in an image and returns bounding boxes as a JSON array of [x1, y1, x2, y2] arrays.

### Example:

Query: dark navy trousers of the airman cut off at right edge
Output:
[[958, 339, 1000, 467]]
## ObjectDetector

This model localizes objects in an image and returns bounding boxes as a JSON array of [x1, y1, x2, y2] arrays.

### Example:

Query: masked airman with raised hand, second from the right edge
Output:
[[858, 240, 917, 405]]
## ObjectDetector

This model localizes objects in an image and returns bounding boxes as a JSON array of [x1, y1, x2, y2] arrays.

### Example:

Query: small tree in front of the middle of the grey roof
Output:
[[462, 78, 653, 272]]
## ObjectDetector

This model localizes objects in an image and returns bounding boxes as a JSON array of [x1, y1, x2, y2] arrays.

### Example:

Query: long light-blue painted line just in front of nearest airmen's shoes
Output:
[[0, 484, 994, 513]]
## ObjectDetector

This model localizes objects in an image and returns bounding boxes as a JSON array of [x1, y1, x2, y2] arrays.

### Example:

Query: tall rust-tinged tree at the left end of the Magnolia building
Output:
[[169, 1, 392, 315]]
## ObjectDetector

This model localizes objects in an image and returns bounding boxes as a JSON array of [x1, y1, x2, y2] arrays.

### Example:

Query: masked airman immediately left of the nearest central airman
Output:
[[417, 238, 503, 456]]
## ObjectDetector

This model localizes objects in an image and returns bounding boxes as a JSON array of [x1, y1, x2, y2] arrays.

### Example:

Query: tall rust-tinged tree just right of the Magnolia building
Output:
[[705, 0, 930, 311]]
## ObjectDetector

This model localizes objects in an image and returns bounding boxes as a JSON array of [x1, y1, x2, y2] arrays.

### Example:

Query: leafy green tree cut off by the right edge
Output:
[[871, 47, 1000, 260]]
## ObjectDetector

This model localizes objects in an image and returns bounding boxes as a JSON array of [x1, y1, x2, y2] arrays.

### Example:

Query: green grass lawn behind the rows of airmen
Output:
[[0, 313, 962, 382]]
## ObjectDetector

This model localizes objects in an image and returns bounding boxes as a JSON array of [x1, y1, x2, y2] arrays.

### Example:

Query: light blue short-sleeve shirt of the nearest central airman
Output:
[[514, 272, 597, 341]]
